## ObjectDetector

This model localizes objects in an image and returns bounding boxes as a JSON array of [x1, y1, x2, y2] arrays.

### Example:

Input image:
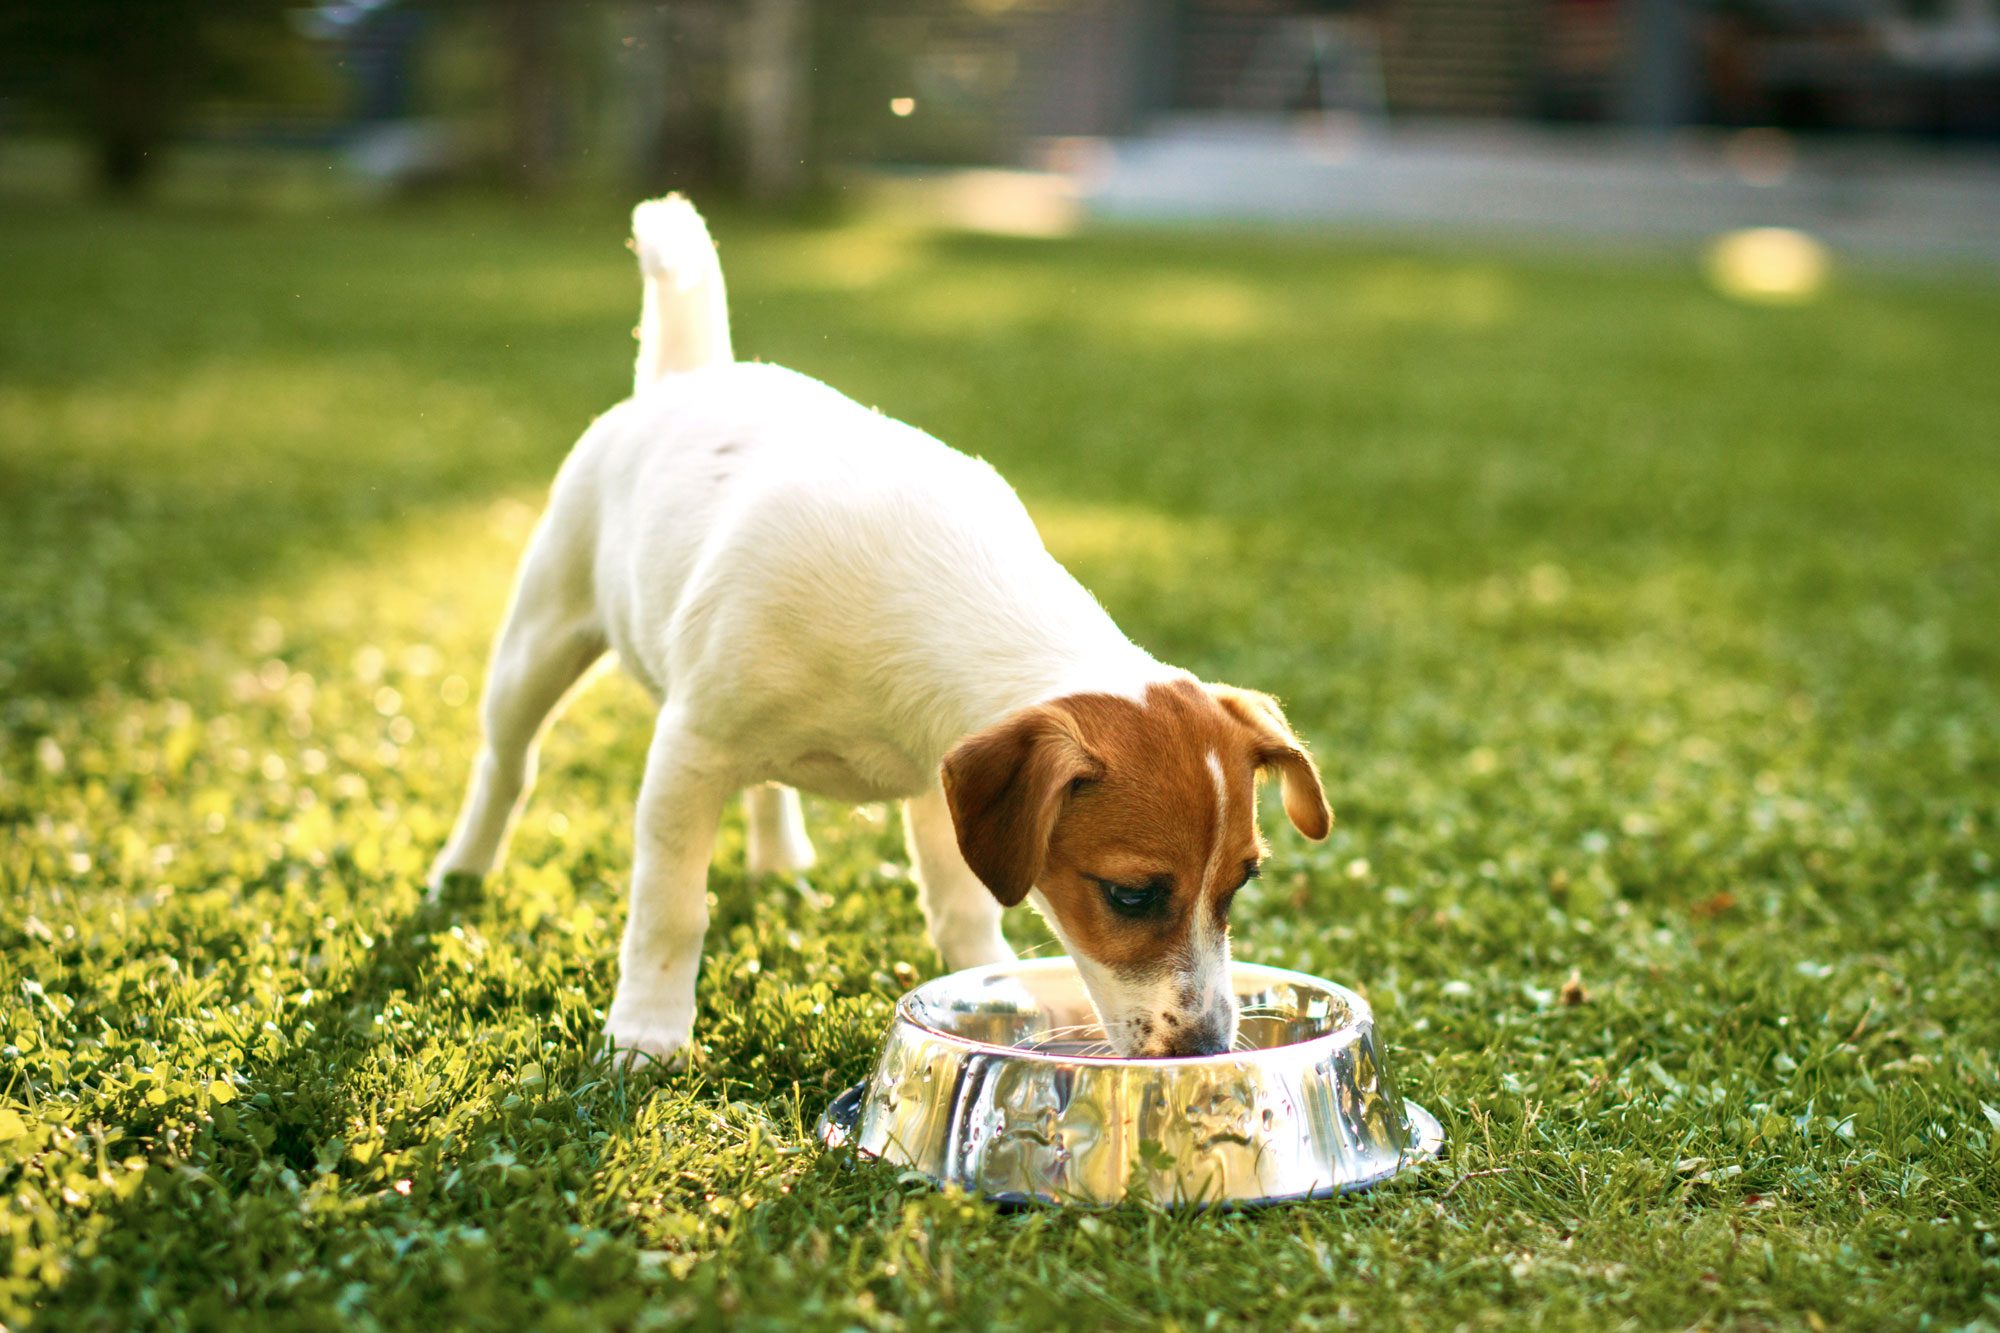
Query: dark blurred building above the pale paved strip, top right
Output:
[[996, 0, 2000, 136]]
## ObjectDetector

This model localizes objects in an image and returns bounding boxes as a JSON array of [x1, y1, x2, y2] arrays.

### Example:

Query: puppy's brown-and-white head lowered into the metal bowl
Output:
[[944, 679, 1332, 1055]]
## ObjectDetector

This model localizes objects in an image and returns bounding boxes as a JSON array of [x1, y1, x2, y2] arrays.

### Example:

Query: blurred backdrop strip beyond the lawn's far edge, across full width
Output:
[[0, 0, 2000, 266]]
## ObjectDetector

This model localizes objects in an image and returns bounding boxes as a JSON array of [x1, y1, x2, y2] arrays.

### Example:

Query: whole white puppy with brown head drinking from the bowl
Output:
[[432, 196, 1332, 1057]]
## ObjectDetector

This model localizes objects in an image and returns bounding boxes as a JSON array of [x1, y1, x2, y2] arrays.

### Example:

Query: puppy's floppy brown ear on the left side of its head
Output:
[[944, 703, 1100, 907]]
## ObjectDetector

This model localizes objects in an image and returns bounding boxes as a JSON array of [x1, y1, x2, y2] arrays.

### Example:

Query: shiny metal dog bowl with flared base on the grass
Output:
[[820, 959, 1444, 1207]]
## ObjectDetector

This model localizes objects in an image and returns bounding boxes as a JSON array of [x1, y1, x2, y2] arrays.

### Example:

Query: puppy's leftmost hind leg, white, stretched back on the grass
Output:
[[430, 506, 606, 893]]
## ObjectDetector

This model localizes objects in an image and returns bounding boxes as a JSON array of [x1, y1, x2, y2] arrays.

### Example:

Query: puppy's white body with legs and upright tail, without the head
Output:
[[432, 200, 1184, 1057]]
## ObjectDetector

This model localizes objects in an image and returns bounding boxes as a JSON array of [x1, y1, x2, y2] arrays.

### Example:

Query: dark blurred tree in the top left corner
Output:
[[0, 0, 300, 196]]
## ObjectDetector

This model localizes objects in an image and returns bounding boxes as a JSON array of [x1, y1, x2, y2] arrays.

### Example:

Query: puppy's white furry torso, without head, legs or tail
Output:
[[568, 362, 1166, 801]]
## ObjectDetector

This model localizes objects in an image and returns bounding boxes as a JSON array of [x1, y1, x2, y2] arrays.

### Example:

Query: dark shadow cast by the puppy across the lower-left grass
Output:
[[38, 883, 670, 1327]]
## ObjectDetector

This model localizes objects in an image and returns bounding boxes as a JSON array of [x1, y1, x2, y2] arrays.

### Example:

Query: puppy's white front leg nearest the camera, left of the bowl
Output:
[[604, 707, 736, 1059]]
